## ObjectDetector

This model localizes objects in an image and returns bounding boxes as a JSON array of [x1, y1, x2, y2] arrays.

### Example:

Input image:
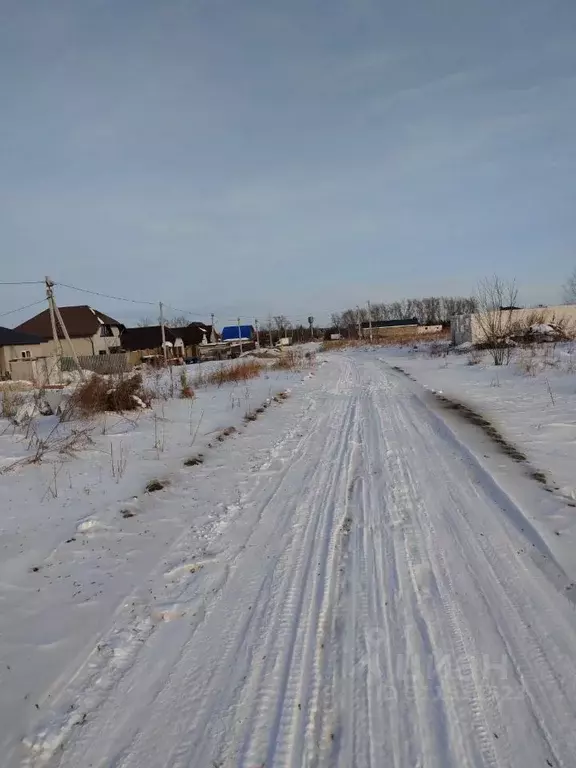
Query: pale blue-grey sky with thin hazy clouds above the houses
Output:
[[0, 0, 576, 325]]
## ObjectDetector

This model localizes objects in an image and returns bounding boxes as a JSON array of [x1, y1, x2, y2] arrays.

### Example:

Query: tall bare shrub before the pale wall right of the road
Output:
[[475, 275, 518, 365]]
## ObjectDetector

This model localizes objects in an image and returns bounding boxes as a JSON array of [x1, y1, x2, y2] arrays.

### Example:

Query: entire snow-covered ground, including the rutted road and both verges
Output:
[[0, 350, 576, 768]]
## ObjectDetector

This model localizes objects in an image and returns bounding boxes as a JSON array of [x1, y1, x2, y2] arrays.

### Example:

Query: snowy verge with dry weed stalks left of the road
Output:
[[0, 363, 308, 765]]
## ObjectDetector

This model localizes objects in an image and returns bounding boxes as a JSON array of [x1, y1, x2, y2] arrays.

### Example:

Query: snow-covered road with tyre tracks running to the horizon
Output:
[[20, 356, 576, 768]]
